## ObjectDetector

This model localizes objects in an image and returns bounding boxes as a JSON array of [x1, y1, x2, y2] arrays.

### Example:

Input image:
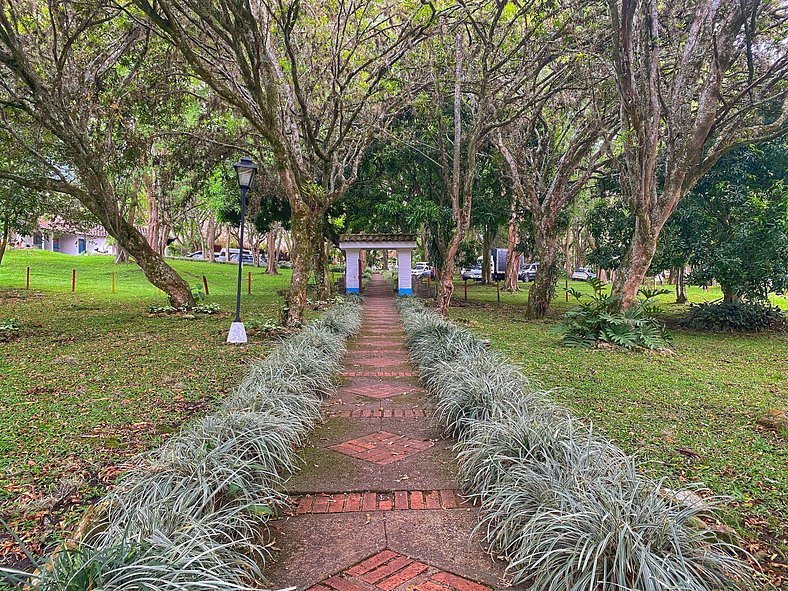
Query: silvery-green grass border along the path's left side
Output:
[[0, 300, 361, 591]]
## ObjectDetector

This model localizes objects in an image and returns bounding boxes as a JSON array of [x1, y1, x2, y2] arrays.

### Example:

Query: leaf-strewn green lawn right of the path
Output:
[[451, 283, 788, 581]]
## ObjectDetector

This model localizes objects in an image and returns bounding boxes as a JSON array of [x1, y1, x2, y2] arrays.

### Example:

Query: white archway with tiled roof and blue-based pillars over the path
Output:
[[339, 234, 416, 296]]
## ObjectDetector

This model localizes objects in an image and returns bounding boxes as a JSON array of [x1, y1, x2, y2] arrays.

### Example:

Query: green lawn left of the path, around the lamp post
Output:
[[0, 251, 304, 561]]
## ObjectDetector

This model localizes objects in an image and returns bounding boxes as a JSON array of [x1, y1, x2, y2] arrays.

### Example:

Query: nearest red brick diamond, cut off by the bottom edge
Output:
[[307, 550, 492, 591]]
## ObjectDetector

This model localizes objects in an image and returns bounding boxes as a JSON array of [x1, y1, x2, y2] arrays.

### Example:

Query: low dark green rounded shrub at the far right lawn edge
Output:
[[681, 301, 786, 332]]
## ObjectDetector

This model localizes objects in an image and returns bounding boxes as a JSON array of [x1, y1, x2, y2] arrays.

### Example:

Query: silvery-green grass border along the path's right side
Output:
[[399, 299, 753, 591]]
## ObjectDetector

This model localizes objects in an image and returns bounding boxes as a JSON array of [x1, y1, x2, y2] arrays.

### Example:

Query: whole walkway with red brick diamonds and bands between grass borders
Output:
[[268, 277, 505, 591]]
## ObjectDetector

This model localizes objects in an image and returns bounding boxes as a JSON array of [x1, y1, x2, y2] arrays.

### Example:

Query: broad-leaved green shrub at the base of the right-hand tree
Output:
[[557, 279, 670, 350]]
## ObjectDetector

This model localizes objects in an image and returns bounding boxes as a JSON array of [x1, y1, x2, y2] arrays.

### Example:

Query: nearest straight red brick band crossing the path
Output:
[[290, 489, 472, 515]]
